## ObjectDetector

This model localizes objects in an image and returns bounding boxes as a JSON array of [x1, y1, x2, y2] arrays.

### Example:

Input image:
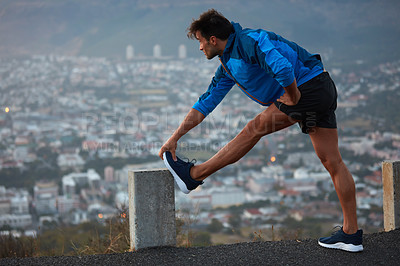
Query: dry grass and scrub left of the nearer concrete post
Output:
[[0, 208, 130, 258]]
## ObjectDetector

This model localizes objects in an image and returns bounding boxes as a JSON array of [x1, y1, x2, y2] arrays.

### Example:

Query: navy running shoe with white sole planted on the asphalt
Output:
[[318, 227, 364, 252]]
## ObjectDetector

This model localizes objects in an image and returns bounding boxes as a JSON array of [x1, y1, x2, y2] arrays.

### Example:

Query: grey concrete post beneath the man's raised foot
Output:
[[128, 170, 176, 251]]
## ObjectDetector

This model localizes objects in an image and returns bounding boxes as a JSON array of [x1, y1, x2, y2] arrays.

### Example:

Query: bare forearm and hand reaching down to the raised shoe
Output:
[[158, 108, 205, 161]]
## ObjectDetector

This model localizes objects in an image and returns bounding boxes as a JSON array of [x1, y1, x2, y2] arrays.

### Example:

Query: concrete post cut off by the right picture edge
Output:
[[382, 161, 400, 231]]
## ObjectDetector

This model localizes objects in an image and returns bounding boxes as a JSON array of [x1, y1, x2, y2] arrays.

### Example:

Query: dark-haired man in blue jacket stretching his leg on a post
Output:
[[159, 9, 363, 252]]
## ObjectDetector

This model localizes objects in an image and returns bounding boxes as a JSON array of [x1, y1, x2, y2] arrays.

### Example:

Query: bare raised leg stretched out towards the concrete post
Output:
[[190, 104, 296, 181]]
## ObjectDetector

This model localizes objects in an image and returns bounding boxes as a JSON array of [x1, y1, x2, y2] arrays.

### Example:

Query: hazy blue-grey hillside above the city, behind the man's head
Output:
[[0, 0, 400, 61]]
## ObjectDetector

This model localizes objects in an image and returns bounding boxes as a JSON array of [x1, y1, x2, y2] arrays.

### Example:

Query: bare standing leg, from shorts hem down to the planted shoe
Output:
[[310, 127, 358, 234]]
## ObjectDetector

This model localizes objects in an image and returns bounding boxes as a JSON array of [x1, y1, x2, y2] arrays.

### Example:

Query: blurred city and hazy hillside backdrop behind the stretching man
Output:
[[0, 0, 400, 254]]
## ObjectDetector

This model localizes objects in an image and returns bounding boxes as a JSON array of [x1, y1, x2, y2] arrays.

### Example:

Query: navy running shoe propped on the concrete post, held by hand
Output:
[[163, 151, 204, 194]]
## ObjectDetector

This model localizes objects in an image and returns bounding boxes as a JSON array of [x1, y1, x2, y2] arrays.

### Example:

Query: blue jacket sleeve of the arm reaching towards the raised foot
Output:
[[193, 65, 235, 116]]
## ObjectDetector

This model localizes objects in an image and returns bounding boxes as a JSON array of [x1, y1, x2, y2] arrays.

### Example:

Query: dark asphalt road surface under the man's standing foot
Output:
[[0, 229, 400, 266]]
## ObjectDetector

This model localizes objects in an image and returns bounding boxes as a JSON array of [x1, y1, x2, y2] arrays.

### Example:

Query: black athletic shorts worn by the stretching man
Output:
[[274, 72, 337, 134]]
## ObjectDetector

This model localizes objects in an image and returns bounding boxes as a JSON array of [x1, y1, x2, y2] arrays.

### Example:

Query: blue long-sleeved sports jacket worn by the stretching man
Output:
[[193, 22, 324, 116]]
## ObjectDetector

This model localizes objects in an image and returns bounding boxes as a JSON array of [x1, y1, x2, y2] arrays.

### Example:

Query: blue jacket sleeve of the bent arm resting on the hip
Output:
[[246, 32, 295, 87]]
